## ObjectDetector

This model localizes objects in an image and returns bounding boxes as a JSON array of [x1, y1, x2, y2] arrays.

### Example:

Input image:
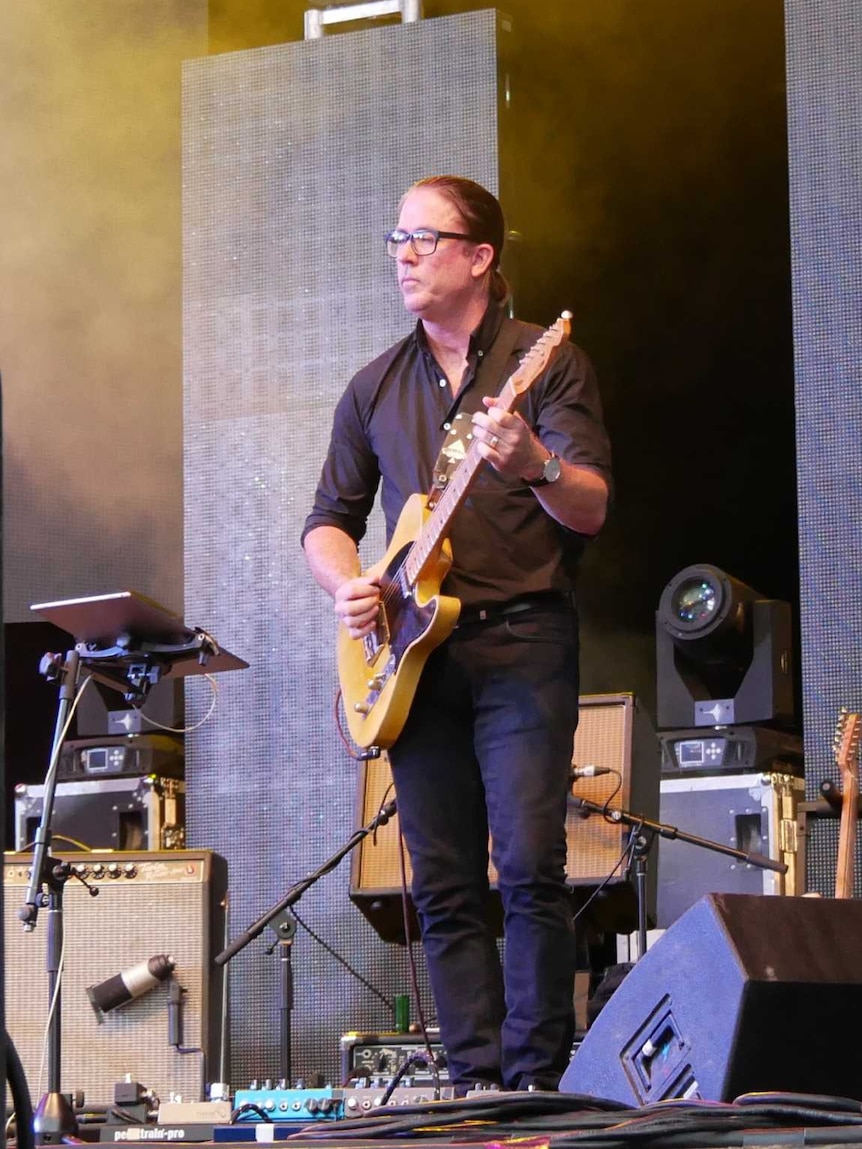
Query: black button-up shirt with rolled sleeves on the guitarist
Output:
[[302, 302, 610, 607]]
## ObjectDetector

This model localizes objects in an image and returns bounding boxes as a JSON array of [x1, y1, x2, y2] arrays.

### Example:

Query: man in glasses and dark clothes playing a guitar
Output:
[[303, 176, 610, 1094]]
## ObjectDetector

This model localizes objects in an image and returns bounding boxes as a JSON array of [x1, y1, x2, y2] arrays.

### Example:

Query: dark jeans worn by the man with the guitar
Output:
[[390, 603, 578, 1089]]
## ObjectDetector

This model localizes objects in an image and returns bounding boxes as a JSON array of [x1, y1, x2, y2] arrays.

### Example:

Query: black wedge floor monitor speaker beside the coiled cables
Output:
[[560, 894, 862, 1105]]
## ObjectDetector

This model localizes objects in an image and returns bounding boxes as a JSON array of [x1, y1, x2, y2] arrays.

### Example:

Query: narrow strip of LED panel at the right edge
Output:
[[785, 0, 862, 893]]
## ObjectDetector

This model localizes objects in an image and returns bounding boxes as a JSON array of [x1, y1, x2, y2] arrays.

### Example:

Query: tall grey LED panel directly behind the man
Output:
[[183, 10, 510, 1085]]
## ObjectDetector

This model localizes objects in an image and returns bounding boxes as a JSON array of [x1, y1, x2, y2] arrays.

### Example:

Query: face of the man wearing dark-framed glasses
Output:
[[398, 187, 480, 322]]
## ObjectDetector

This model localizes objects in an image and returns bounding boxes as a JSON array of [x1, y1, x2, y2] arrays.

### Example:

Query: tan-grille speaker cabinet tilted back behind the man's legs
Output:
[[351, 694, 660, 941]]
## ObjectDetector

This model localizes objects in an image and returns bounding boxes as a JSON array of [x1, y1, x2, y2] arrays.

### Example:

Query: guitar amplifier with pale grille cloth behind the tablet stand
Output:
[[3, 850, 226, 1105]]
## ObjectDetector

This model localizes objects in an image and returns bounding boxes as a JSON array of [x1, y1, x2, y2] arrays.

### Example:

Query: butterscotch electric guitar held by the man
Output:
[[338, 311, 571, 749]]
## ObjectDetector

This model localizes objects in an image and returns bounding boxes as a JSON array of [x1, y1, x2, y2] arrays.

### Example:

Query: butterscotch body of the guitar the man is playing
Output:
[[338, 494, 461, 749]]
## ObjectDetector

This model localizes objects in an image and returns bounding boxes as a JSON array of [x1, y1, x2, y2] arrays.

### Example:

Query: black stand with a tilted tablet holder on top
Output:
[[18, 591, 248, 1144]]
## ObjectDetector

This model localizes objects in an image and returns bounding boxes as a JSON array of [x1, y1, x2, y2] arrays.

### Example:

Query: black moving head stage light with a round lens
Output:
[[655, 563, 793, 727]]
